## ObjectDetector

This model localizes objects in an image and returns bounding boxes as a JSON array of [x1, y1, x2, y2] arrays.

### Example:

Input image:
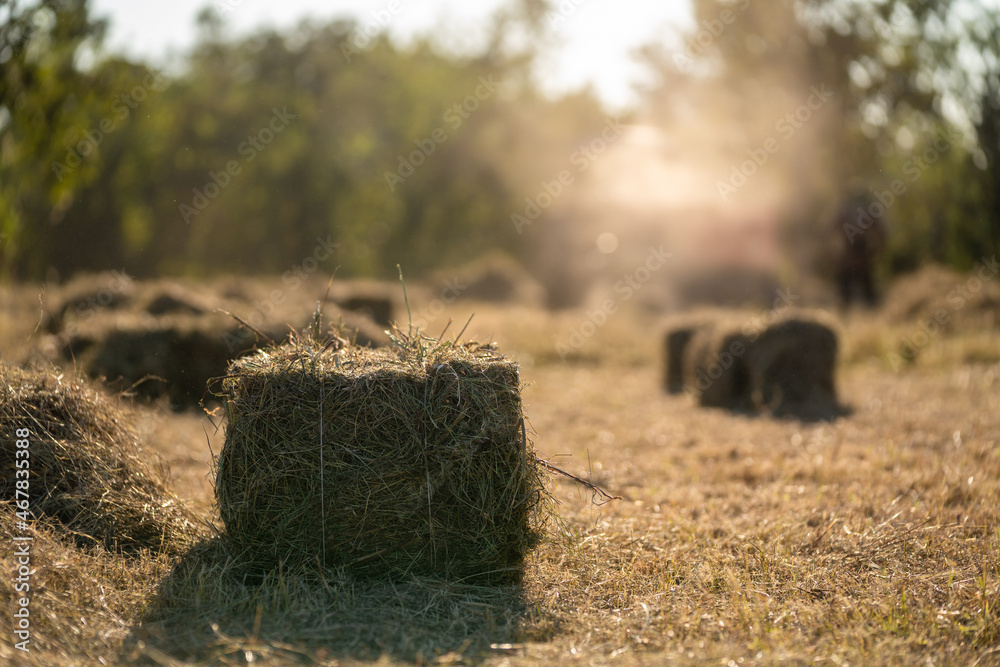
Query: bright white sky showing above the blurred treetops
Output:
[[92, 0, 692, 107]]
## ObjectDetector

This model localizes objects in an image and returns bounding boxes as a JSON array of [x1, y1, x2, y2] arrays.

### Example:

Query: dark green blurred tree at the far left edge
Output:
[[0, 0, 107, 278]]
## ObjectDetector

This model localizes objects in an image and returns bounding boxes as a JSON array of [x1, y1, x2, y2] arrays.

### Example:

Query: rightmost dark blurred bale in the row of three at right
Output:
[[746, 314, 838, 419]]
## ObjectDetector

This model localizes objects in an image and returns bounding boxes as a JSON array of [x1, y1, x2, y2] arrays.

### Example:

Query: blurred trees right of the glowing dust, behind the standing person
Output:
[[641, 0, 1000, 278]]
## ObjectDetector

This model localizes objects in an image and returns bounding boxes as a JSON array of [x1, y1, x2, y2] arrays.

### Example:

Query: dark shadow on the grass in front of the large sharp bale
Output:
[[121, 536, 528, 664]]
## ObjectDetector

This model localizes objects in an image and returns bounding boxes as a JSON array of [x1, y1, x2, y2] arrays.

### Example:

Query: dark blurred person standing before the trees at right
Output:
[[831, 190, 886, 308]]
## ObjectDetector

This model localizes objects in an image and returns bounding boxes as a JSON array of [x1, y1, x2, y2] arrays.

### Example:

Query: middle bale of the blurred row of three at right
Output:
[[683, 321, 751, 410]]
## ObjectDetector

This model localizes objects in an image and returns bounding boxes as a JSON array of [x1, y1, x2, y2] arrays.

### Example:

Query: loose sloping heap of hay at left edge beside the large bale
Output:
[[0, 365, 199, 554]]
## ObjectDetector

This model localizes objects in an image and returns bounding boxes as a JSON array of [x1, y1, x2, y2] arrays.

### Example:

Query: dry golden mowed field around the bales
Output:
[[0, 272, 1000, 666]]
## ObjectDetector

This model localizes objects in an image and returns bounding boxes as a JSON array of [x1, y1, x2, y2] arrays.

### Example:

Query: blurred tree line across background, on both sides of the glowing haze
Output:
[[0, 0, 1000, 280]]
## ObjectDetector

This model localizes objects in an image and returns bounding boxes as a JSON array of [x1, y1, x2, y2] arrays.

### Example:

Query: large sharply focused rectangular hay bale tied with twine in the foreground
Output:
[[215, 340, 544, 582]]
